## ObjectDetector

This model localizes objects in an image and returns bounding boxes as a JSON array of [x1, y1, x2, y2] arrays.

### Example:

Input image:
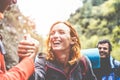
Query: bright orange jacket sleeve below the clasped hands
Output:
[[0, 58, 34, 80]]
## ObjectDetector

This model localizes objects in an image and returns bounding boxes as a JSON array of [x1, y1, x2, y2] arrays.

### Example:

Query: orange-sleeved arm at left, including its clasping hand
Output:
[[0, 34, 37, 80]]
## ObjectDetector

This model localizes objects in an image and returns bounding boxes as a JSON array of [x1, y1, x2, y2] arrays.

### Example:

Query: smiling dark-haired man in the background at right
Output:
[[94, 39, 120, 80]]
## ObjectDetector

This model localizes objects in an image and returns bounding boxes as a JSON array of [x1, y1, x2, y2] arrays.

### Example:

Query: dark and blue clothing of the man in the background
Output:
[[93, 56, 120, 80]]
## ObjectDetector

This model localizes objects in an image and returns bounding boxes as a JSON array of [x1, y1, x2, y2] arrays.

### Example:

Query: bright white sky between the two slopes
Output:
[[17, 0, 82, 36]]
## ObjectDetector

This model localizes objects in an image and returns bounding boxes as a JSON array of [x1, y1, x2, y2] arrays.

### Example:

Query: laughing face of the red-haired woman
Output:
[[50, 23, 71, 52]]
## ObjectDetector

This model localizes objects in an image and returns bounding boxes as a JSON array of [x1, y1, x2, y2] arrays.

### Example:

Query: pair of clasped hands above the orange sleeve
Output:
[[18, 34, 39, 60]]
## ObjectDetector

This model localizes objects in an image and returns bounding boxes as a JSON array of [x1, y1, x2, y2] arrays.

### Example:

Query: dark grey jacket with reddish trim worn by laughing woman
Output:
[[30, 53, 96, 80]]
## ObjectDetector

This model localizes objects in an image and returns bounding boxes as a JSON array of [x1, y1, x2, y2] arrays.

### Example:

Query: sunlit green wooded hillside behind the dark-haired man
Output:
[[68, 0, 120, 57]]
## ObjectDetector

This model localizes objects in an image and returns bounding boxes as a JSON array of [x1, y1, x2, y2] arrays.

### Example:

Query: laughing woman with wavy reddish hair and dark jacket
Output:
[[30, 21, 96, 80]]
